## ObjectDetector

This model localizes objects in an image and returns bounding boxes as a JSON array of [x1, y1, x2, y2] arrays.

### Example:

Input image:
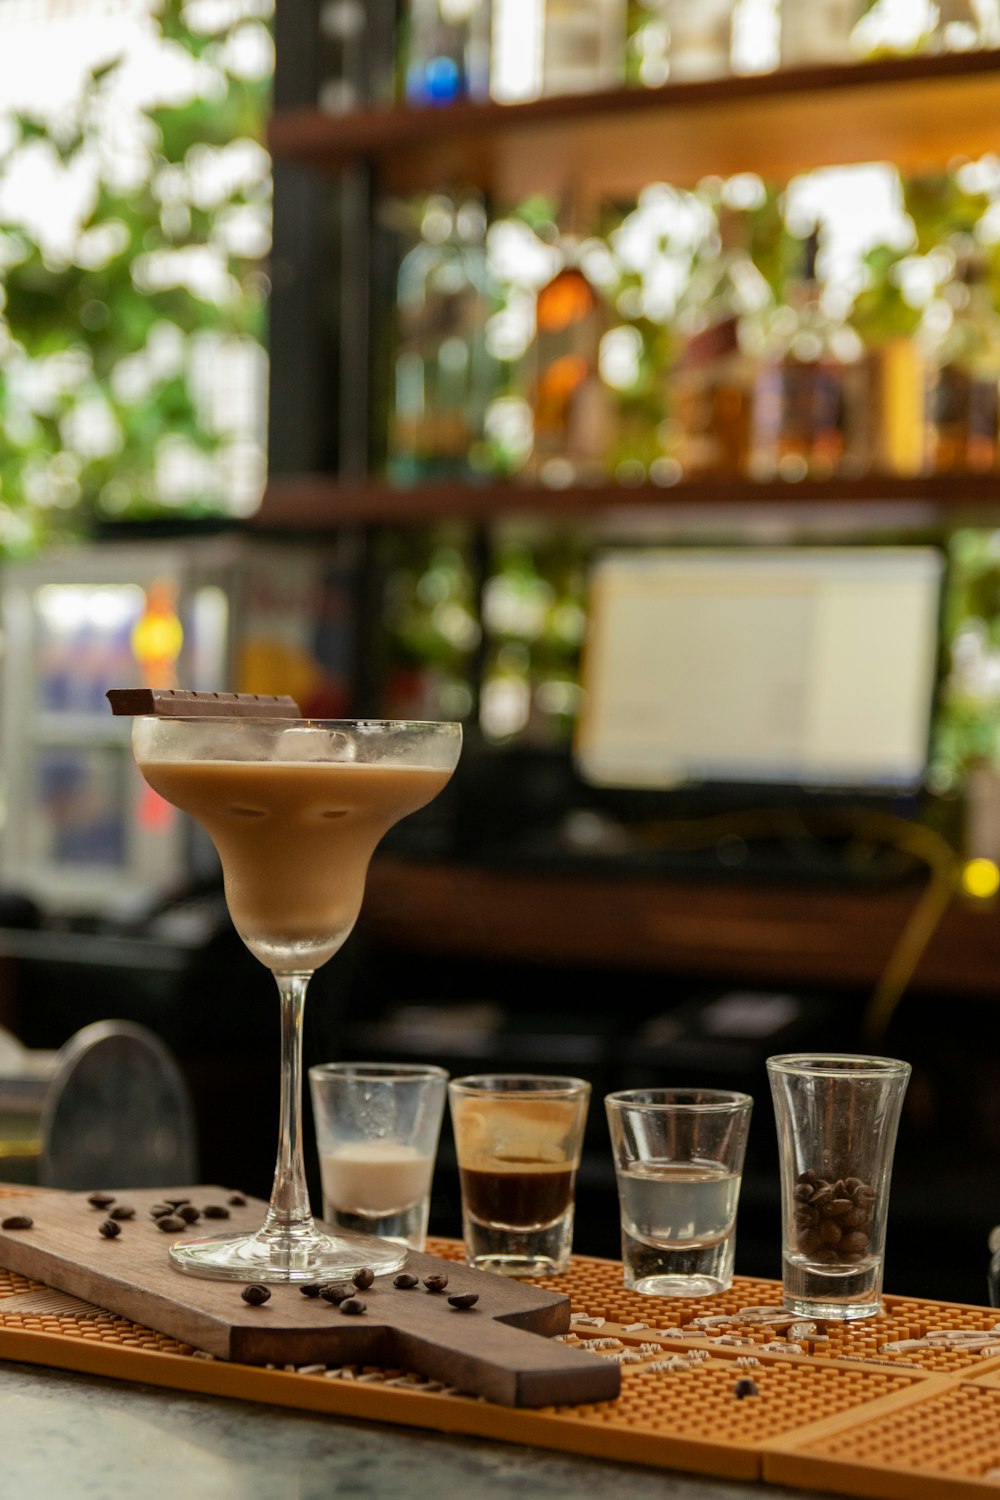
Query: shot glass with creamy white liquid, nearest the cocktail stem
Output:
[[309, 1062, 448, 1250]]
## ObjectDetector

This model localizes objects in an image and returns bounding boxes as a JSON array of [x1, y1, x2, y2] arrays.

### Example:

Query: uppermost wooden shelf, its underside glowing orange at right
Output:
[[270, 51, 1000, 203]]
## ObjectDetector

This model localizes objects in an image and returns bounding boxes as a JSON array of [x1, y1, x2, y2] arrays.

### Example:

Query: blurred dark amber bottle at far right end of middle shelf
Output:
[[924, 251, 1000, 474]]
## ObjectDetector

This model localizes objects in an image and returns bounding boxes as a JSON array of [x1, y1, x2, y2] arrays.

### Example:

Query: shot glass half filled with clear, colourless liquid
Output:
[[604, 1089, 754, 1298]]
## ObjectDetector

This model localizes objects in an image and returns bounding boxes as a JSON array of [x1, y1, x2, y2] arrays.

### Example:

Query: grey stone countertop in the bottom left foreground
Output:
[[0, 1361, 813, 1500]]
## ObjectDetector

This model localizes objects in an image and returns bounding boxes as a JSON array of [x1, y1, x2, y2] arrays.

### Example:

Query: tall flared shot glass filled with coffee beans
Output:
[[768, 1053, 910, 1319]]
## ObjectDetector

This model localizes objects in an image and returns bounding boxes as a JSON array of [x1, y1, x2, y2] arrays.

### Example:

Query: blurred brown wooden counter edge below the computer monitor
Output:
[[361, 855, 1000, 996]]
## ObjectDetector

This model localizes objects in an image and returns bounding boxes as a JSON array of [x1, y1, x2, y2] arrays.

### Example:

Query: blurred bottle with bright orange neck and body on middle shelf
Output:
[[523, 219, 615, 489]]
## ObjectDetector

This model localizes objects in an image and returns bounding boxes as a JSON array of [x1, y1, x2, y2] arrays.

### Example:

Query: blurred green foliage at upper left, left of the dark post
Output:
[[0, 0, 270, 555]]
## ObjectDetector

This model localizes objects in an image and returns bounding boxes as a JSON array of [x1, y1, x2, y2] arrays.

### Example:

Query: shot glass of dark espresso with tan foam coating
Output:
[[448, 1074, 591, 1277]]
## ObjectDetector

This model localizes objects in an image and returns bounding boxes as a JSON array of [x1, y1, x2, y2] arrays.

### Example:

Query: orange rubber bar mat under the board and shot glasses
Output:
[[0, 1206, 1000, 1500]]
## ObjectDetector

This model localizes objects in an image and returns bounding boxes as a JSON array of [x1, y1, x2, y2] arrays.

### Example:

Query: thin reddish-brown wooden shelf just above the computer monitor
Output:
[[252, 474, 1000, 531]]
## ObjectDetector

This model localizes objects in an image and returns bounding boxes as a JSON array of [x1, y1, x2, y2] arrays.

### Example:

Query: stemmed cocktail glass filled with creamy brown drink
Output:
[[132, 716, 462, 1281]]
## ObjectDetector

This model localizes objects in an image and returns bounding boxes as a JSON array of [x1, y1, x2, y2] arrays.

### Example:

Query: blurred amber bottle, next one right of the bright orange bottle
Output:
[[667, 207, 772, 479]]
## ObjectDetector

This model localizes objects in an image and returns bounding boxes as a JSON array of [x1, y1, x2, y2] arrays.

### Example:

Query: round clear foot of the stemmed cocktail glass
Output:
[[169, 1229, 408, 1283]]
